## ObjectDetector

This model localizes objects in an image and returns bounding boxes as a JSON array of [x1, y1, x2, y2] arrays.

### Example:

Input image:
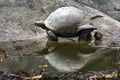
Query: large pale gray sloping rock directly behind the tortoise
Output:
[[0, 0, 120, 46]]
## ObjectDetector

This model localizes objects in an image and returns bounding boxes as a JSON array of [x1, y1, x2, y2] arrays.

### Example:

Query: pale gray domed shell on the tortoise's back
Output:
[[44, 7, 84, 34]]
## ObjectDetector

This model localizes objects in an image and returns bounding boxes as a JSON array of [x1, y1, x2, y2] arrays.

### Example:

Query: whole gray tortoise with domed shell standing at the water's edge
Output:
[[35, 6, 102, 41]]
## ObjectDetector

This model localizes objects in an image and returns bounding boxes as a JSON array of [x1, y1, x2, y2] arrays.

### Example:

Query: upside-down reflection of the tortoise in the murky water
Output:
[[41, 41, 97, 72]]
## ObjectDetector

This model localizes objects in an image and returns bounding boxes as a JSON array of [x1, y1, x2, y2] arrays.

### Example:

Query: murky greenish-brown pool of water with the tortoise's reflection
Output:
[[0, 41, 120, 73]]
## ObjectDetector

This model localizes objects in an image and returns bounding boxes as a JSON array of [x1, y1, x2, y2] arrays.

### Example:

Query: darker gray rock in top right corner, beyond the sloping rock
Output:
[[75, 0, 120, 21]]
